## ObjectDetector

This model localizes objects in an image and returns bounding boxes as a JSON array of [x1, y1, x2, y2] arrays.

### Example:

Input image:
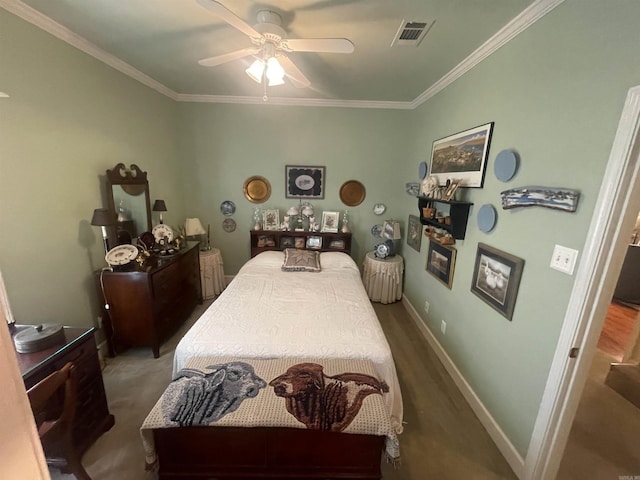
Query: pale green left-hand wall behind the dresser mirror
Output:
[[0, 9, 183, 332]]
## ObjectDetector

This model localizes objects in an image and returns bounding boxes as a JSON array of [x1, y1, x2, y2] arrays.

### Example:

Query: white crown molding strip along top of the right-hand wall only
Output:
[[411, 0, 564, 108]]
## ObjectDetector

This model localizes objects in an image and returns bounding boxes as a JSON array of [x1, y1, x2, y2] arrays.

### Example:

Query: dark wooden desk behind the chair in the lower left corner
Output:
[[16, 327, 114, 453]]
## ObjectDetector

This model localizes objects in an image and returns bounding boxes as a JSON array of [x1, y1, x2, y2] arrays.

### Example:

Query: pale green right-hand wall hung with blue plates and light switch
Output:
[[404, 0, 640, 456]]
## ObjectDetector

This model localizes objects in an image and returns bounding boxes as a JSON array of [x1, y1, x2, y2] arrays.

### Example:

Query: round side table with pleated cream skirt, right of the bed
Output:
[[362, 252, 404, 303]]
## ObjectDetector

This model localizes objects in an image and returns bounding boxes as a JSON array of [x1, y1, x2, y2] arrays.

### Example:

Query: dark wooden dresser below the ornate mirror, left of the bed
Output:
[[96, 242, 202, 358]]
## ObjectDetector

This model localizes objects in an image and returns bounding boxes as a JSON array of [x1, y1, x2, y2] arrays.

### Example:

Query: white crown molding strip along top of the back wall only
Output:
[[177, 93, 414, 110]]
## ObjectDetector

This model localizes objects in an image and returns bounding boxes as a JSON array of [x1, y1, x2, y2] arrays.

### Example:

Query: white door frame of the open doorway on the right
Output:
[[524, 86, 640, 480]]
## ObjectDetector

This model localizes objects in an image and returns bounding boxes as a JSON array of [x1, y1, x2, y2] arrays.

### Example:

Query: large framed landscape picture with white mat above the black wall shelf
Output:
[[431, 122, 493, 188]]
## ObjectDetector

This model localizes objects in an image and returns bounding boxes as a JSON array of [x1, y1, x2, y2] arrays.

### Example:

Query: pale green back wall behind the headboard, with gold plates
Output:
[[180, 103, 417, 275]]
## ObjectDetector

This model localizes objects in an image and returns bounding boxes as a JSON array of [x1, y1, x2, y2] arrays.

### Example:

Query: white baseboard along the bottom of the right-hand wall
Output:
[[402, 295, 524, 478]]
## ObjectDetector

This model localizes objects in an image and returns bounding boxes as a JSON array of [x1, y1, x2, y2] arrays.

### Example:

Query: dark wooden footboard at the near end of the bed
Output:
[[153, 427, 384, 480]]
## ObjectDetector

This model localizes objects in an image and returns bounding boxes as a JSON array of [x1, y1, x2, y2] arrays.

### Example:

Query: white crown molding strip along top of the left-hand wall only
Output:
[[0, 0, 178, 100]]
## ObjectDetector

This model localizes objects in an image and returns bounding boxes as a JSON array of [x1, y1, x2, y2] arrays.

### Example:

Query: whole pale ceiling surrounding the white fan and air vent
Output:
[[0, 0, 562, 108]]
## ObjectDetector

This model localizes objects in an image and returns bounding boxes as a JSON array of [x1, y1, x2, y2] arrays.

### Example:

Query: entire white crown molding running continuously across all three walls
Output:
[[0, 0, 564, 110]]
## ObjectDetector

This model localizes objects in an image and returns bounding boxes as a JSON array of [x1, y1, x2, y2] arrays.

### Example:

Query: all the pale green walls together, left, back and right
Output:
[[0, 0, 640, 466]]
